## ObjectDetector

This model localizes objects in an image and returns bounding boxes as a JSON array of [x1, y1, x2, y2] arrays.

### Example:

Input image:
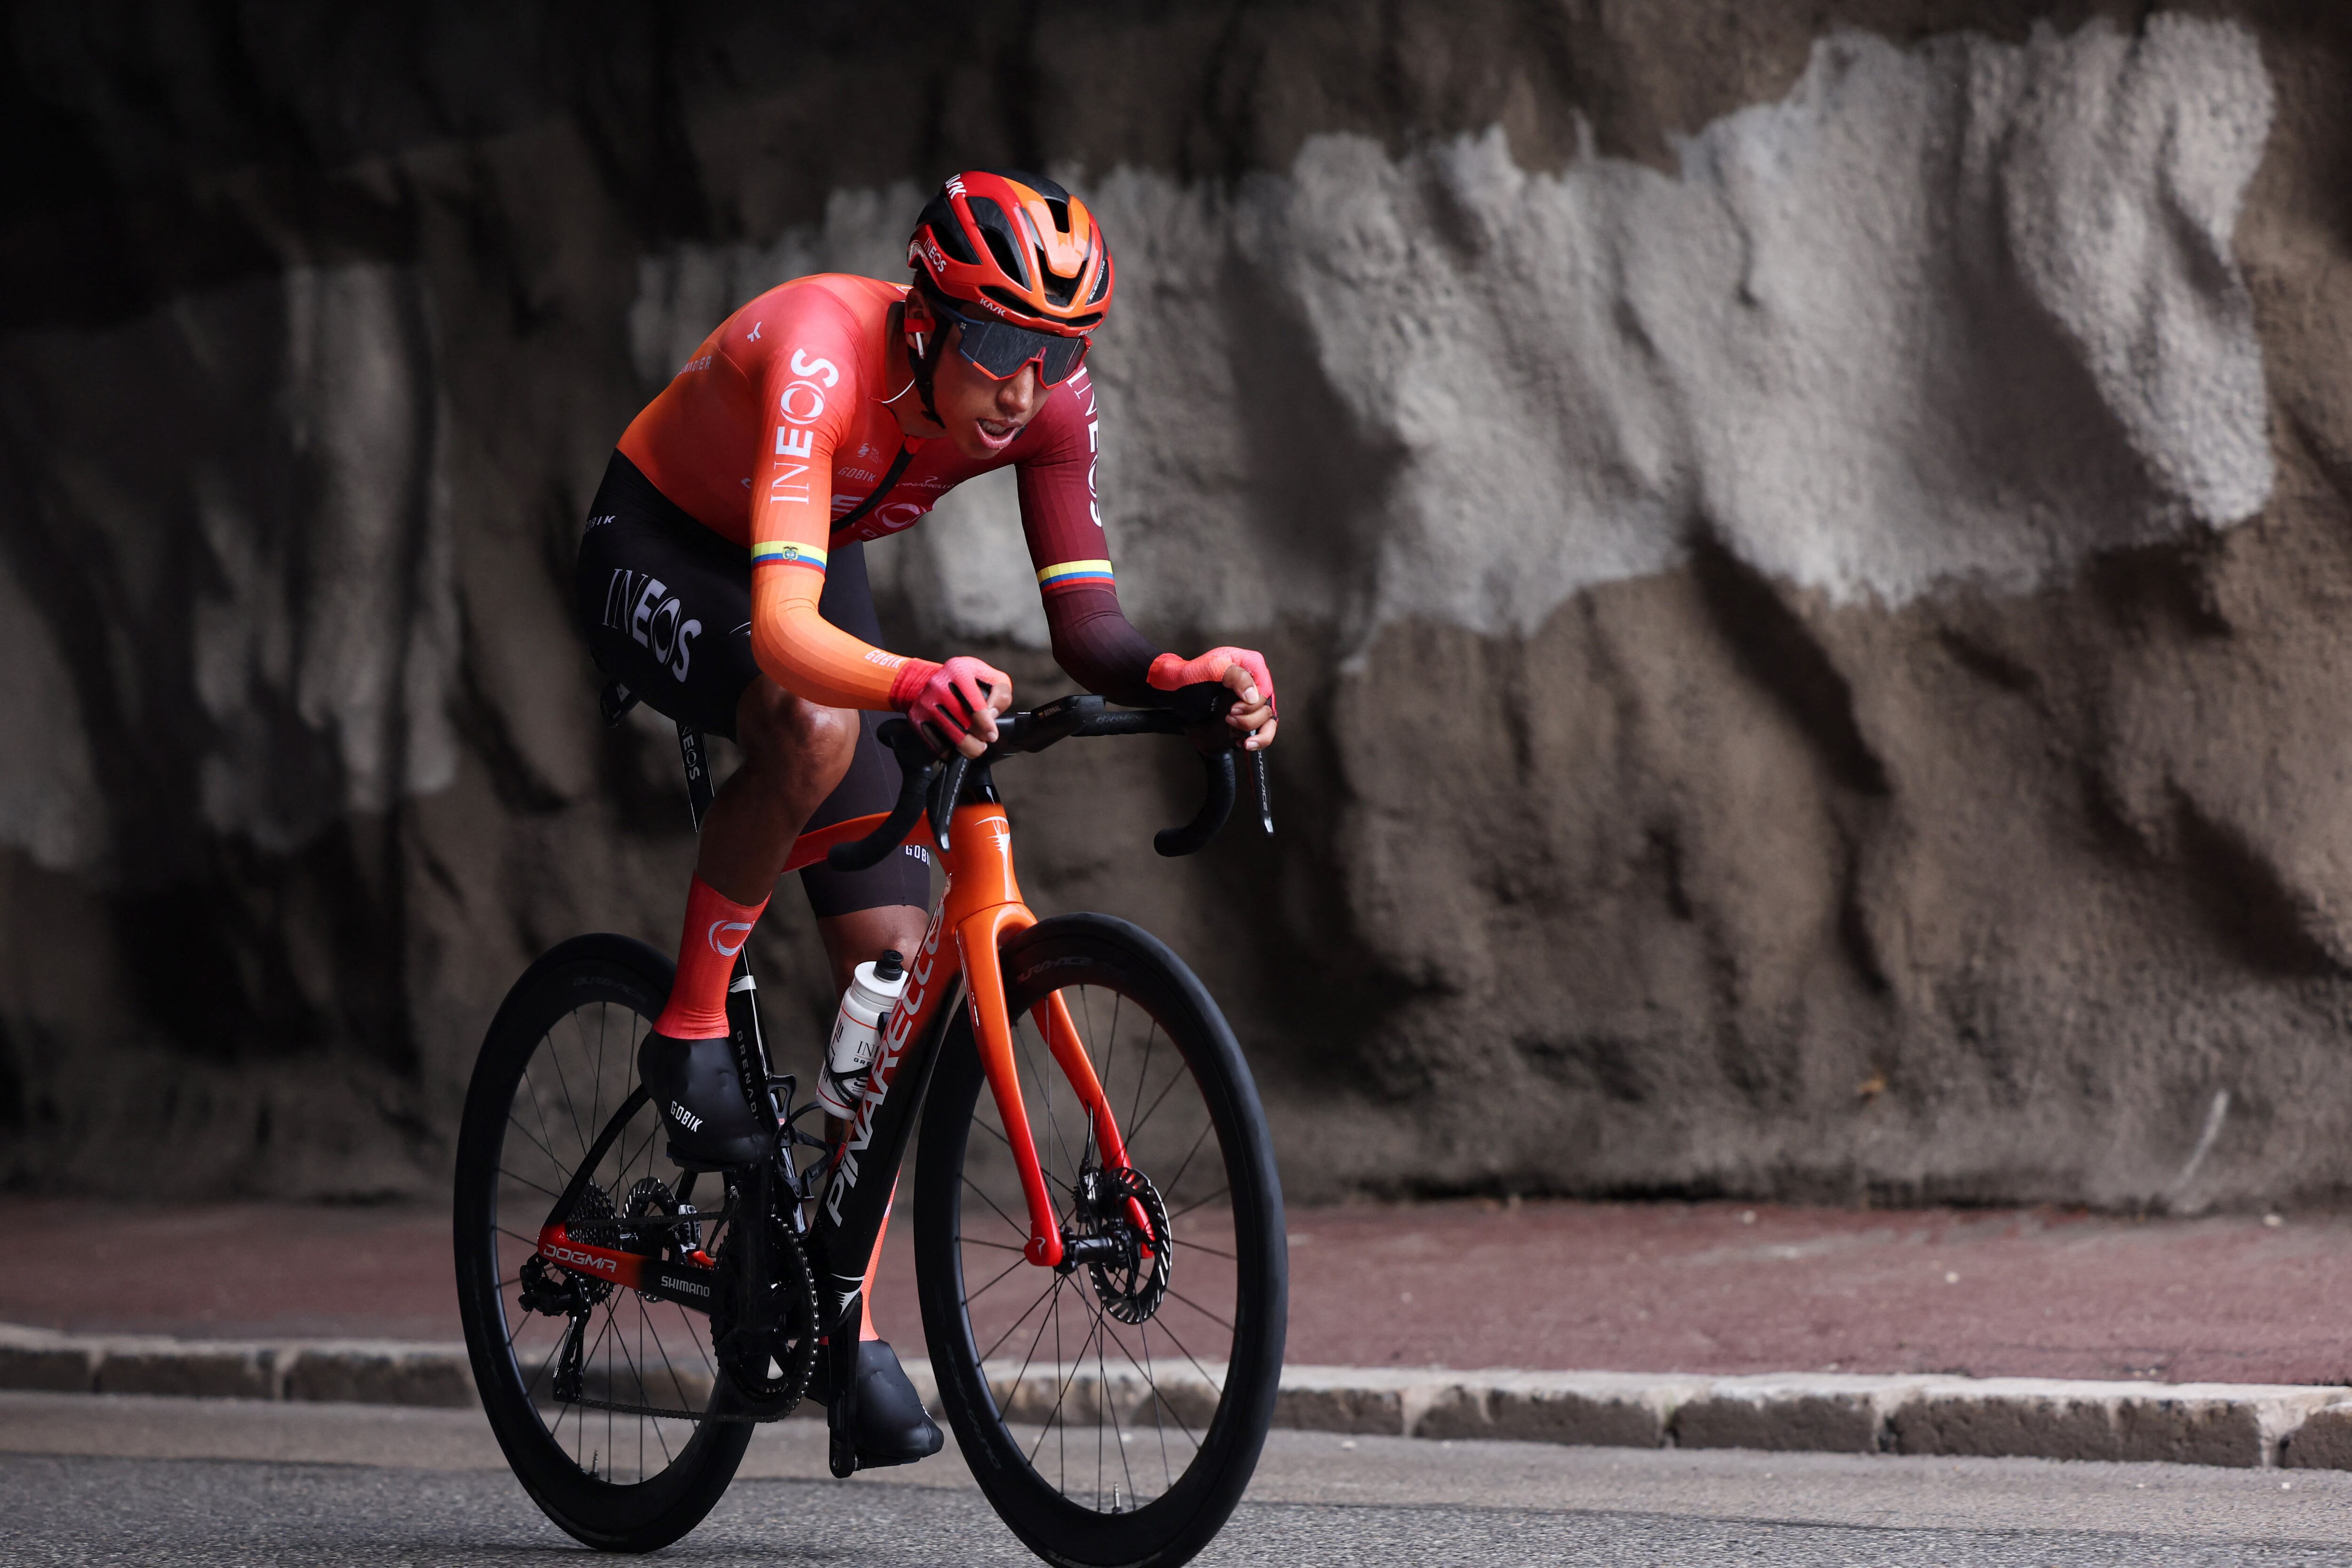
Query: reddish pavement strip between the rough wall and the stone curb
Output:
[[0, 1196, 2352, 1382]]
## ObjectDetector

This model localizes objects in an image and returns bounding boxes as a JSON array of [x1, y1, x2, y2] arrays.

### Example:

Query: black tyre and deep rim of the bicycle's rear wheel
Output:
[[454, 936, 750, 1552]]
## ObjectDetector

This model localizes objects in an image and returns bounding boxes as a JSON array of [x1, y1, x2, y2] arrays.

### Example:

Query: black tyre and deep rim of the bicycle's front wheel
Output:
[[915, 915, 1289, 1568]]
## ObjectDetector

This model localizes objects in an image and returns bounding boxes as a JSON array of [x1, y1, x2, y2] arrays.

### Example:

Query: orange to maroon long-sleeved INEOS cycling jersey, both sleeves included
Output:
[[621, 273, 1157, 708]]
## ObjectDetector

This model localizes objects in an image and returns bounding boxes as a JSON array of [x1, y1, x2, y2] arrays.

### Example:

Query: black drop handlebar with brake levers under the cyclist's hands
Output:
[[826, 684, 1275, 872]]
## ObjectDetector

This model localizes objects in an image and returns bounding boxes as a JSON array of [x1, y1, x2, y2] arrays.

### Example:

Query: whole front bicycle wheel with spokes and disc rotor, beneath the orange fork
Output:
[[915, 915, 1289, 1568]]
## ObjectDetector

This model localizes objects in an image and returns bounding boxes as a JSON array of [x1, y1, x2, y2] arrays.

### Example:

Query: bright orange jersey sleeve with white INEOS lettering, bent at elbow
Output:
[[750, 308, 910, 708]]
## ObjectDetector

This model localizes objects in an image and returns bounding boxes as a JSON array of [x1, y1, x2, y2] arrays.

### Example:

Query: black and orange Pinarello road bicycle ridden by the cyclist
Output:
[[454, 684, 1289, 1566]]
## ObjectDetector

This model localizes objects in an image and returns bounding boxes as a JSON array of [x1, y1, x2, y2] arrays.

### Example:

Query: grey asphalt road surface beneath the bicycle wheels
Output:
[[0, 1394, 2352, 1568]]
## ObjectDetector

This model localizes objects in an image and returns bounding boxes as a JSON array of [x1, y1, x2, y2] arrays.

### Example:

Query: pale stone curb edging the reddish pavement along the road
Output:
[[0, 1323, 2352, 1469]]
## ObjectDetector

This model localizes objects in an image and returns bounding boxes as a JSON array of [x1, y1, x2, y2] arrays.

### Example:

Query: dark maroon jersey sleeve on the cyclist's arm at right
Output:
[[1016, 372, 1162, 708]]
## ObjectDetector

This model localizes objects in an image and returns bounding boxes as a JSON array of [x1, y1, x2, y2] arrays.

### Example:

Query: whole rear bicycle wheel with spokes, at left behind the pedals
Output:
[[456, 936, 750, 1552]]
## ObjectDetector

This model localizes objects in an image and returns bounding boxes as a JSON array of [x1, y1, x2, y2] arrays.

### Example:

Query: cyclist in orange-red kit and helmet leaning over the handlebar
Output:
[[576, 172, 1275, 1465]]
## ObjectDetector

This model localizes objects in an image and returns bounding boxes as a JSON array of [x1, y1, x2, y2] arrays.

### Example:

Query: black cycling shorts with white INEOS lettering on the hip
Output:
[[574, 451, 931, 919]]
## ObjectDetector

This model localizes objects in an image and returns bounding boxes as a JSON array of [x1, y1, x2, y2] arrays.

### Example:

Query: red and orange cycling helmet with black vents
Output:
[[906, 169, 1112, 339]]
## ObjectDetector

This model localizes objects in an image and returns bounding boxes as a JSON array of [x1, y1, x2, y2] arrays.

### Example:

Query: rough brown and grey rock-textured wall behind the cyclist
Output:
[[0, 0, 2352, 1206]]
